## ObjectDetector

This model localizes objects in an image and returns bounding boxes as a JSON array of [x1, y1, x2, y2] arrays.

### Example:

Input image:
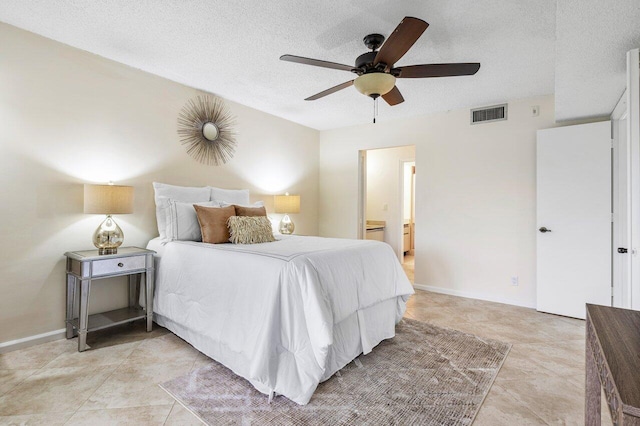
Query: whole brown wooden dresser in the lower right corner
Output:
[[585, 304, 640, 426]]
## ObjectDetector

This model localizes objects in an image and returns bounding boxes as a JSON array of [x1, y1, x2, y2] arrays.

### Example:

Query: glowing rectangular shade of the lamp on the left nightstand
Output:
[[84, 184, 133, 214]]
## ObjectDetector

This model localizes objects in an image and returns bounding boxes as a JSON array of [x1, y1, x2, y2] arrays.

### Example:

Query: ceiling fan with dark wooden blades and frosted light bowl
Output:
[[280, 16, 480, 110]]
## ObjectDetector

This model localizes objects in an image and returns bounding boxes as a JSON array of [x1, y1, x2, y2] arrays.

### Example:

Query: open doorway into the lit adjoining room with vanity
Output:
[[358, 145, 416, 283]]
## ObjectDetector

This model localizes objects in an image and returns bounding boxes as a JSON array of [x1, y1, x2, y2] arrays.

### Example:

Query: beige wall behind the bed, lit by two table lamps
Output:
[[0, 24, 319, 344]]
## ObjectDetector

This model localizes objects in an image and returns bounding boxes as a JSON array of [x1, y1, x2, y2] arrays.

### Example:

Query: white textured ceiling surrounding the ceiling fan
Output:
[[0, 0, 640, 129]]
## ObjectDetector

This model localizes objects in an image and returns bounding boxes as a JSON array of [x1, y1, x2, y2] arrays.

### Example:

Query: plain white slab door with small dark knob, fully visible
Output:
[[537, 121, 611, 318]]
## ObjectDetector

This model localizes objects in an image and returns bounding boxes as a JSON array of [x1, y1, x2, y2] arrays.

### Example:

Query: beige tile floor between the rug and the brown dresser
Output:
[[406, 291, 611, 426]]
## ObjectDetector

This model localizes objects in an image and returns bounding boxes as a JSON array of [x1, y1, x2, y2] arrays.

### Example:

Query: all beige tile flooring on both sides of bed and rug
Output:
[[0, 291, 610, 426]]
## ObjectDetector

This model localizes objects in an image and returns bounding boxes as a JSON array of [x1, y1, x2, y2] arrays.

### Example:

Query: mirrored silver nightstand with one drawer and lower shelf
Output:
[[64, 247, 155, 352]]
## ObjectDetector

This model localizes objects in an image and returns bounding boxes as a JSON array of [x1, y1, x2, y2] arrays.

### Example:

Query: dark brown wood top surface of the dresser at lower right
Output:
[[587, 304, 640, 411]]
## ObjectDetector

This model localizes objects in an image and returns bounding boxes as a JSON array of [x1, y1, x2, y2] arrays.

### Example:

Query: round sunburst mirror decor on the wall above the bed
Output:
[[178, 96, 237, 166]]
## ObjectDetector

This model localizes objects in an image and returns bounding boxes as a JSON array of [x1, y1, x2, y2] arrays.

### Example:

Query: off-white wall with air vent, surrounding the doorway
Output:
[[320, 95, 555, 307]]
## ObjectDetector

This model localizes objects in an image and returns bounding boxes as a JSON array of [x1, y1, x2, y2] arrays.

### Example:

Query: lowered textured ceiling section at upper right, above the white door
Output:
[[555, 0, 640, 121]]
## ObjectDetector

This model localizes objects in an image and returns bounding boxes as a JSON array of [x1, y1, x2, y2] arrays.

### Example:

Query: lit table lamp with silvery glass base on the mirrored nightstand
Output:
[[84, 184, 133, 254]]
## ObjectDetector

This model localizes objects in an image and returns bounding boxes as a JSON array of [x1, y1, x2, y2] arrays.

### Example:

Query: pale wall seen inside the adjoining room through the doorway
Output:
[[366, 145, 416, 255]]
